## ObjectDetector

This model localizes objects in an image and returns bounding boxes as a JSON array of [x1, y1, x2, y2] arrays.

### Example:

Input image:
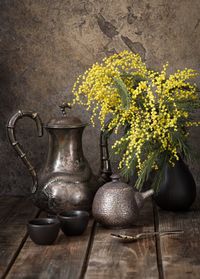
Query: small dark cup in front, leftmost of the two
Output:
[[27, 218, 60, 245]]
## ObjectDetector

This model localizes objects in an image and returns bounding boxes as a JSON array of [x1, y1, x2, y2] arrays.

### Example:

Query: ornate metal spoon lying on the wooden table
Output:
[[111, 230, 184, 242]]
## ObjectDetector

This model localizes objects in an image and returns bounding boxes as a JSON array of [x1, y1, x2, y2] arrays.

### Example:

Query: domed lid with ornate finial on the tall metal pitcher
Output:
[[45, 103, 87, 128]]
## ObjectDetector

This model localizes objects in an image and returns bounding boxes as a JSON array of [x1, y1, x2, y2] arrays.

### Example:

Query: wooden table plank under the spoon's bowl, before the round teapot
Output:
[[85, 201, 158, 279]]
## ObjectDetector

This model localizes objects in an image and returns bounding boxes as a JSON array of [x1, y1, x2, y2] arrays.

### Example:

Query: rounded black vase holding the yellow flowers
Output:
[[154, 158, 196, 211]]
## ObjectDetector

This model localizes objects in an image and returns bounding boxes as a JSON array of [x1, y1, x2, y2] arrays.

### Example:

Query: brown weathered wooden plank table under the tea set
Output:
[[0, 197, 200, 279]]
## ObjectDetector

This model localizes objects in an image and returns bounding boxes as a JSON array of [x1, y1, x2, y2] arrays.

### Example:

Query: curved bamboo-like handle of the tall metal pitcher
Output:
[[7, 110, 43, 193]]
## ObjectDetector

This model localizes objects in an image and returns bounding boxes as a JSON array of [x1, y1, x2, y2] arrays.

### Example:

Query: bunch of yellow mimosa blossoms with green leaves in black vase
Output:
[[72, 51, 200, 189]]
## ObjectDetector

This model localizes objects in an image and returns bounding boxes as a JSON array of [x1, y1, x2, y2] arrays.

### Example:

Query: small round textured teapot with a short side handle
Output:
[[92, 175, 153, 230]]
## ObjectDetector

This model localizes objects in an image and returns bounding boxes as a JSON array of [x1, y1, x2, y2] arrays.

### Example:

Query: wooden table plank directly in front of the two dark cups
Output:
[[6, 220, 93, 279]]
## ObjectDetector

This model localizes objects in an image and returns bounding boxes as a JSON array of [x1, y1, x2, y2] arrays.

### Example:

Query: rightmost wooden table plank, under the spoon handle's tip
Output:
[[157, 195, 200, 279]]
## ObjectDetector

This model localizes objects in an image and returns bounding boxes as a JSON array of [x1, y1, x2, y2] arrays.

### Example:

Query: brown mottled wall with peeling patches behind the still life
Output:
[[0, 0, 200, 195]]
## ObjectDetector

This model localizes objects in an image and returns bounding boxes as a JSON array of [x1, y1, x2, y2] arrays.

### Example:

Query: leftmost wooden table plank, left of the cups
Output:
[[0, 197, 38, 278]]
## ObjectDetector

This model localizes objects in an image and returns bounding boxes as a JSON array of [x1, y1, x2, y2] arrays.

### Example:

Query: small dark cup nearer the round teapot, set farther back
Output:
[[58, 210, 89, 235]]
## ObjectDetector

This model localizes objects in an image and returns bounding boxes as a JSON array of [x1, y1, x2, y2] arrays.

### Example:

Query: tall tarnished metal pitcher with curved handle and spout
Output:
[[7, 104, 111, 214]]
